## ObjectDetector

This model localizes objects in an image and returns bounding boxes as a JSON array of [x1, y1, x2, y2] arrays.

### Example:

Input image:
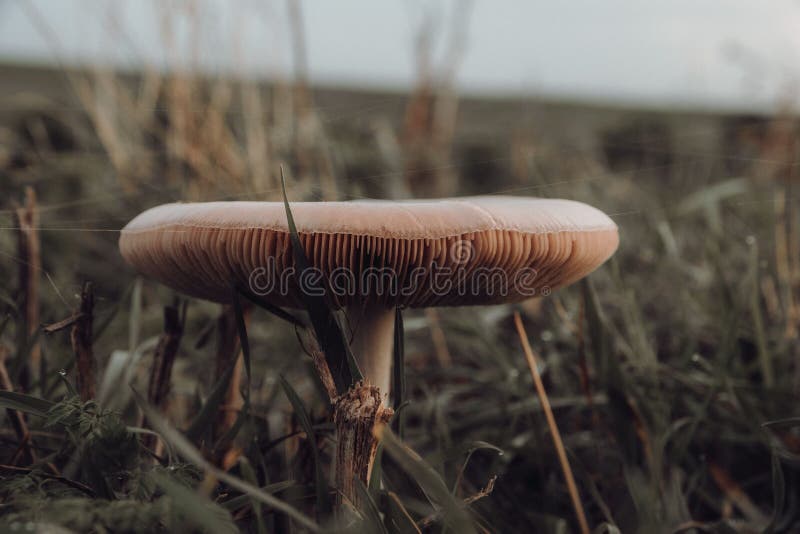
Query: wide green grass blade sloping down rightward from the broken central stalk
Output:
[[375, 425, 475, 534]]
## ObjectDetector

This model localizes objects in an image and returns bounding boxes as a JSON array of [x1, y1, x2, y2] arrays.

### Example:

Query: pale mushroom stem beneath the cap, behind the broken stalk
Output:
[[347, 305, 394, 403]]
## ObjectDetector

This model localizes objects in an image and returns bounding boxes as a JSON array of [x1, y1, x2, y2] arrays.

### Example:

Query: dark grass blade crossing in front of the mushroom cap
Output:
[[281, 167, 363, 395]]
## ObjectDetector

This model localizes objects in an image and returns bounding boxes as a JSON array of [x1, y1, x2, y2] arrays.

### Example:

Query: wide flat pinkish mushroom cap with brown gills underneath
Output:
[[119, 196, 619, 307]]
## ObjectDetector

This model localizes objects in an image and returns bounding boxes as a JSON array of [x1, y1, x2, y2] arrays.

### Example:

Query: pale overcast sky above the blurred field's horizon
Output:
[[0, 0, 800, 109]]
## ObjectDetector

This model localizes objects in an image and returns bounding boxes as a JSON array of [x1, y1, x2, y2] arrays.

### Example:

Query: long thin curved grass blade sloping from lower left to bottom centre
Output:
[[131, 386, 320, 532]]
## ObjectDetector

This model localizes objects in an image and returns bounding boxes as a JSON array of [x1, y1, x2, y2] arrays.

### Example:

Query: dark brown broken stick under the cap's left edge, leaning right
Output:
[[143, 306, 185, 452]]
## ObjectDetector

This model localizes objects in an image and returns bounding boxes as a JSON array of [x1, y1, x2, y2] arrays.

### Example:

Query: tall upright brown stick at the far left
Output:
[[16, 187, 42, 390]]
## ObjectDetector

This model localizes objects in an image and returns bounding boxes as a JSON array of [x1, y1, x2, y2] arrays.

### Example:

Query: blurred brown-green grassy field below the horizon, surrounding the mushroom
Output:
[[0, 56, 800, 533]]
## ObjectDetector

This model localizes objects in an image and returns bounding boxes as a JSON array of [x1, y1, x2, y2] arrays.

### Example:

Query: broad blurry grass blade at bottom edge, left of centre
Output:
[[150, 472, 239, 533]]
